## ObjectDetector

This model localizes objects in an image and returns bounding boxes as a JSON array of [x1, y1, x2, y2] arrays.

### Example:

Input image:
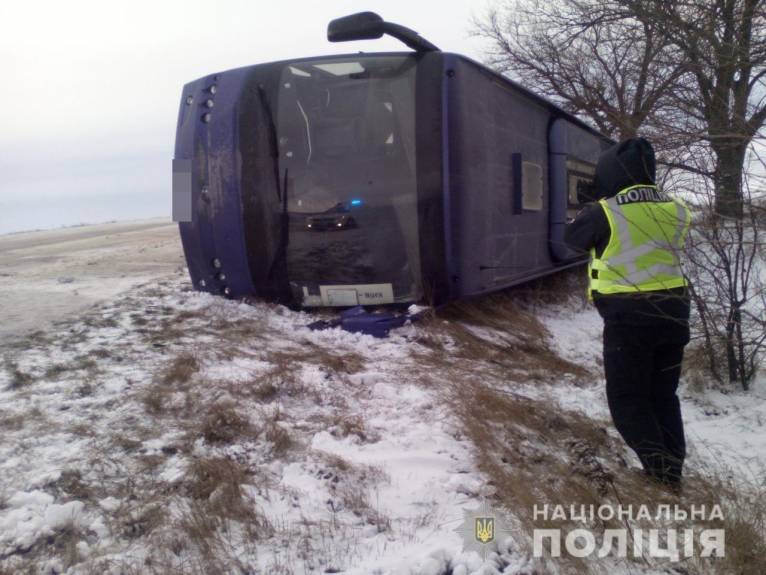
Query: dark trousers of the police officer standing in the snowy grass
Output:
[[604, 320, 689, 483]]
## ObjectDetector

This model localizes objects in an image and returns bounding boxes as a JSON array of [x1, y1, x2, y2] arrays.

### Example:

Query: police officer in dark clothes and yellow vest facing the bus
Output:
[[565, 138, 690, 485]]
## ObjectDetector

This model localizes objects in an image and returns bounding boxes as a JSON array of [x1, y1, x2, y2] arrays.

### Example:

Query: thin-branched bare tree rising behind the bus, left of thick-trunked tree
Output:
[[474, 0, 685, 139]]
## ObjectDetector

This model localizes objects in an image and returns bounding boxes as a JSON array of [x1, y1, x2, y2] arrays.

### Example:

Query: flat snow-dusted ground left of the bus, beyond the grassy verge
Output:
[[0, 219, 183, 345]]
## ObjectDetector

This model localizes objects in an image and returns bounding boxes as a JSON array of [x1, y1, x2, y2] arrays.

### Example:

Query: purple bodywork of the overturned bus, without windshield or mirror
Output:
[[174, 52, 610, 316]]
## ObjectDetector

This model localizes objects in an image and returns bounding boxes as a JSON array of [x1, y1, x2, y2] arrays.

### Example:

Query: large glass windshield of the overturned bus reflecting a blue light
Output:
[[275, 55, 422, 306]]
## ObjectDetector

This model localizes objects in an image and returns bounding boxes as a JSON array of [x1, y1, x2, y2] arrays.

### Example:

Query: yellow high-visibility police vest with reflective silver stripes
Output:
[[588, 185, 691, 297]]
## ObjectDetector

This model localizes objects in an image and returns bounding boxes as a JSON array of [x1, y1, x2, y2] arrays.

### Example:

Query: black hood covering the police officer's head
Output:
[[594, 138, 656, 200]]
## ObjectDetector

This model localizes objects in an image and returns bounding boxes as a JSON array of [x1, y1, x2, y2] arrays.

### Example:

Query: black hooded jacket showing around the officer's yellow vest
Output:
[[564, 138, 689, 325]]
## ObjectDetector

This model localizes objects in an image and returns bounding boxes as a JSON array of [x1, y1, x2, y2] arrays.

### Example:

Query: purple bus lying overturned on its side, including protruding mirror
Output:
[[173, 12, 610, 307]]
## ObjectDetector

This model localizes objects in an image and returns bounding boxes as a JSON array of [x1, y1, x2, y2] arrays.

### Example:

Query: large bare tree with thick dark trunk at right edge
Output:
[[619, 0, 766, 217]]
